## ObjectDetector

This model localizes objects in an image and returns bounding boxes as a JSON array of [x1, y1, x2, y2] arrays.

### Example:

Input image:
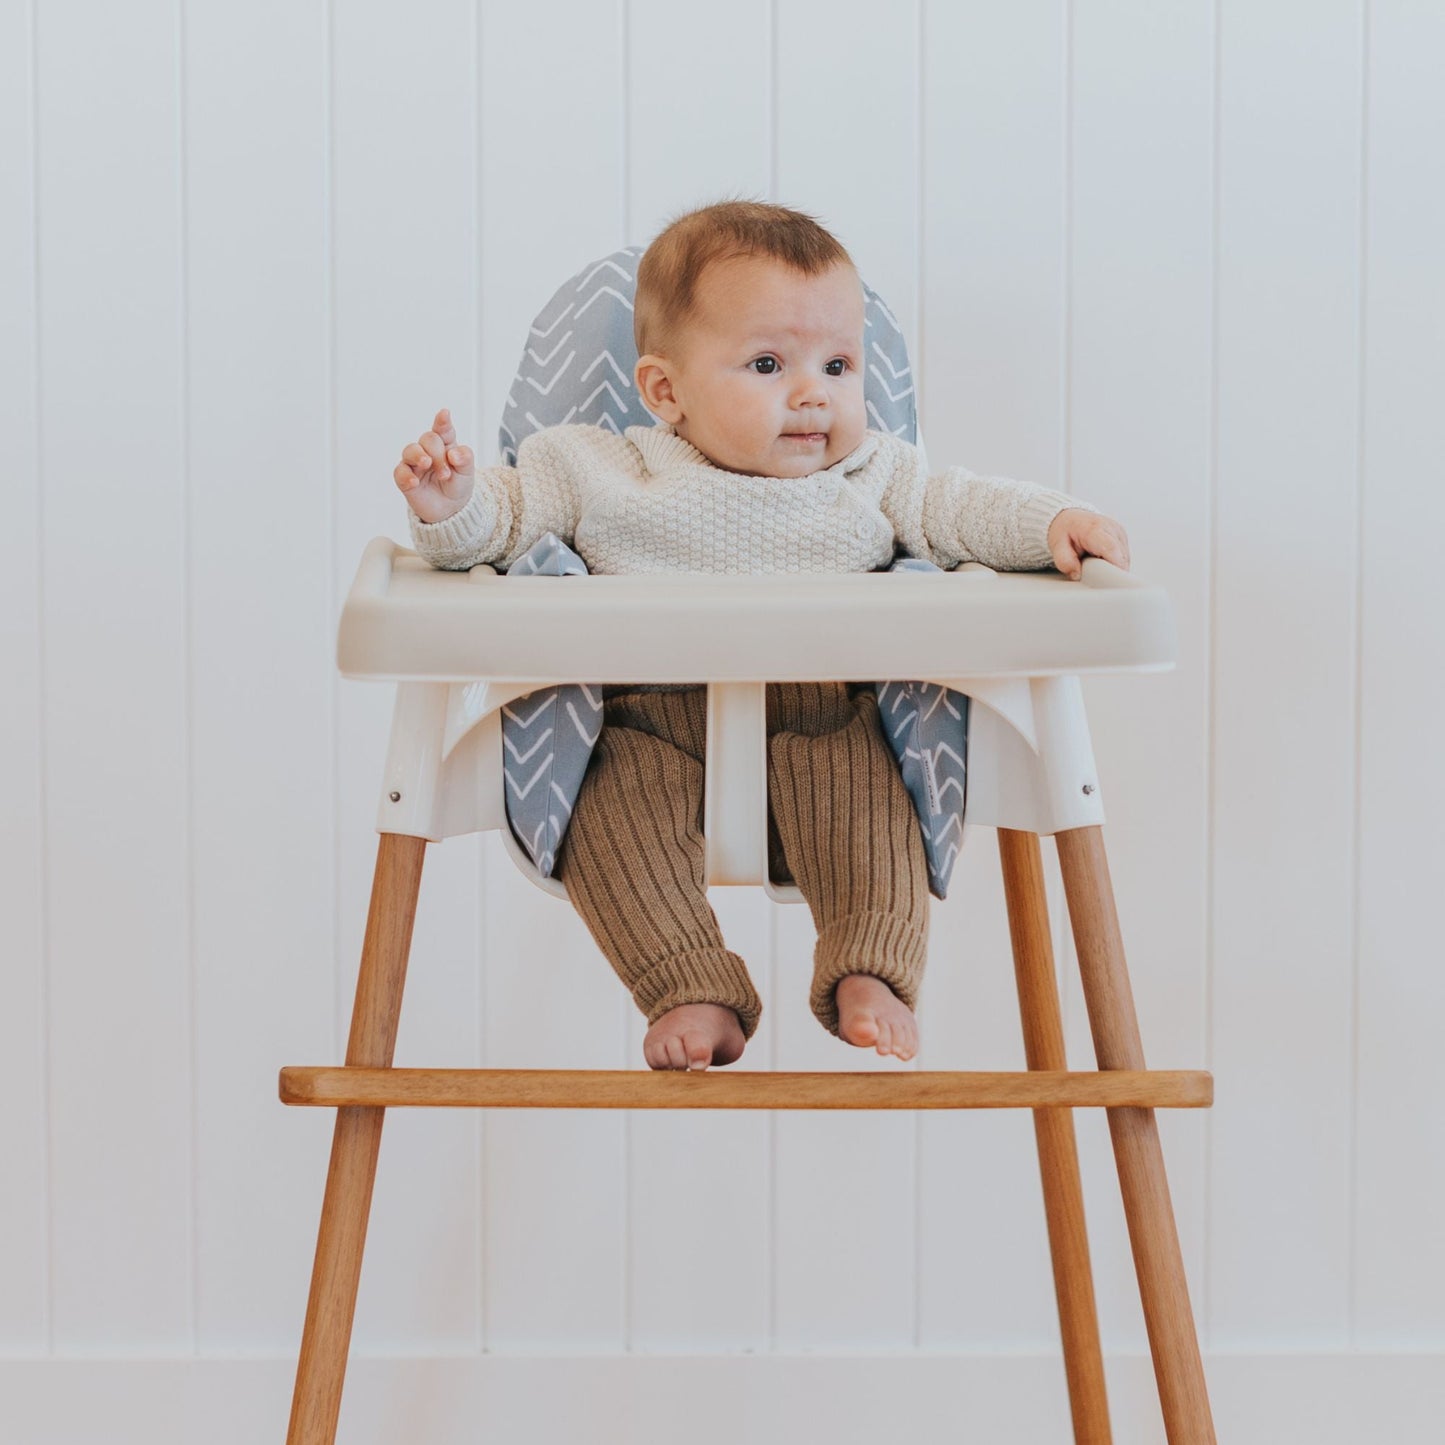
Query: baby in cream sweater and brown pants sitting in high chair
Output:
[[394, 201, 1129, 1069]]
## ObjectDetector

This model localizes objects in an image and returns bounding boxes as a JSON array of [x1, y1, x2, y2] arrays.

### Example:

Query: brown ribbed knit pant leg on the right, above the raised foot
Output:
[[767, 683, 928, 1033]]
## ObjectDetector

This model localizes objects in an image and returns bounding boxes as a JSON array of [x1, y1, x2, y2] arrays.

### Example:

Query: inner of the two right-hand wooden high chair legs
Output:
[[998, 828, 1113, 1445]]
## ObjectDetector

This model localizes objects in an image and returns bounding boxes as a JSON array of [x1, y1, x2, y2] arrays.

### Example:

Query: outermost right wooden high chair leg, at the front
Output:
[[1055, 827, 1215, 1445]]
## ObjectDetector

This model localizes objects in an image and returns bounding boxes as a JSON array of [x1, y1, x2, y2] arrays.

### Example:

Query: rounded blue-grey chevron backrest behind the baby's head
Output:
[[499, 246, 918, 464]]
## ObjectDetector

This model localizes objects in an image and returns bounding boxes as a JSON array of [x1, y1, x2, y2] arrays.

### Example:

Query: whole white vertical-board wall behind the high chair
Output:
[[0, 0, 1445, 1442]]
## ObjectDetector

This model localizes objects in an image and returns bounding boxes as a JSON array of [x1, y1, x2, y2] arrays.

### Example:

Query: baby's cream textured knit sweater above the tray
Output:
[[409, 422, 1092, 572]]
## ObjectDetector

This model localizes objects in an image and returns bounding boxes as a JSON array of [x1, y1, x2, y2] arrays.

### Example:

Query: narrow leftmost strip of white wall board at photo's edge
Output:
[[0, 6, 49, 1353]]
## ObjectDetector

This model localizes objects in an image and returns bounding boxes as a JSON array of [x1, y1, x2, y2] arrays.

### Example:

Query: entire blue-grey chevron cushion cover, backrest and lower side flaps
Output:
[[499, 254, 968, 897]]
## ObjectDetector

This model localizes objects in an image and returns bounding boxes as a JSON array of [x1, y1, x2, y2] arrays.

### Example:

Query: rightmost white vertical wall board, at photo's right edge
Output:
[[1354, 0, 1445, 1350]]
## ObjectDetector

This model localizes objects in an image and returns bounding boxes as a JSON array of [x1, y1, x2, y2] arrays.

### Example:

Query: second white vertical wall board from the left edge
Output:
[[38, 3, 192, 1353]]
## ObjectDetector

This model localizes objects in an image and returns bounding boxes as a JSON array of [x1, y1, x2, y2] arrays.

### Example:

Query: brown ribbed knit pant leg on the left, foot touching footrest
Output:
[[556, 688, 763, 1039]]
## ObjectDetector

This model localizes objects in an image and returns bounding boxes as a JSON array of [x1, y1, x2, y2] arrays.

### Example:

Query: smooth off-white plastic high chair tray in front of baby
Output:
[[337, 538, 1175, 683]]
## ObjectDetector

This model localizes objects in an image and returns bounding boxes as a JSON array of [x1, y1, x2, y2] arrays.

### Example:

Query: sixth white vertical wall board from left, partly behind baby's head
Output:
[[626, 0, 775, 1351]]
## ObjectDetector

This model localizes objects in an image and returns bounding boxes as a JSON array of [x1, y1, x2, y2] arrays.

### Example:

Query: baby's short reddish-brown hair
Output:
[[633, 201, 853, 355]]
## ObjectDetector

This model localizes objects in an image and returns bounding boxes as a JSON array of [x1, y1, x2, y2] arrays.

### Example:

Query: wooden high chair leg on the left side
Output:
[[286, 832, 426, 1445]]
